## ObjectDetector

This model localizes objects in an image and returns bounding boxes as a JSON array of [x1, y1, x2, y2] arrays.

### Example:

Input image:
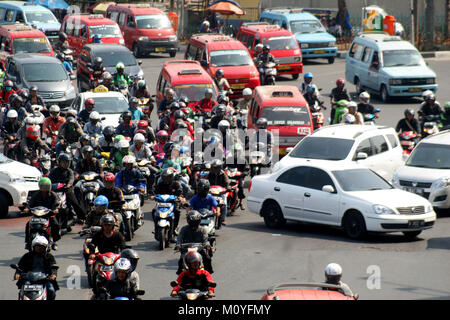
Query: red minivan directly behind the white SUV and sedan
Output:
[[248, 86, 314, 156]]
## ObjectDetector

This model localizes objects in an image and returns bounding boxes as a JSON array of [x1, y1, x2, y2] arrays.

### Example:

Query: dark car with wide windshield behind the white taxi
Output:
[[77, 43, 144, 92]]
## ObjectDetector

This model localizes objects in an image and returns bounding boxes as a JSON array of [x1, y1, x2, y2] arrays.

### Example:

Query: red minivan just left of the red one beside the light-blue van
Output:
[[184, 33, 260, 99]]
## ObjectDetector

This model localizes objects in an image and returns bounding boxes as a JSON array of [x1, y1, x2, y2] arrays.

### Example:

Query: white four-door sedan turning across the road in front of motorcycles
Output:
[[247, 160, 436, 239]]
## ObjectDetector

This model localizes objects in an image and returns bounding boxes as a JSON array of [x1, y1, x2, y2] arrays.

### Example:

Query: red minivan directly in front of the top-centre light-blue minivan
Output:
[[236, 22, 303, 79]]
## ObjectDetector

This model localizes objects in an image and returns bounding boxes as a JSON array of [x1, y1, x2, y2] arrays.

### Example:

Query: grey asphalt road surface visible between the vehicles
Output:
[[0, 52, 450, 300]]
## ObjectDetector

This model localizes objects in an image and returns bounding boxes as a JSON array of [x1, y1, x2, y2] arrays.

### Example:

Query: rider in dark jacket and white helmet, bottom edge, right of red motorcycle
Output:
[[99, 257, 140, 300]]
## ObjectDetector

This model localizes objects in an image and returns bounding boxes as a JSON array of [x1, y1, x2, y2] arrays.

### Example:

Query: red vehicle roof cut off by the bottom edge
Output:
[[261, 283, 359, 300]]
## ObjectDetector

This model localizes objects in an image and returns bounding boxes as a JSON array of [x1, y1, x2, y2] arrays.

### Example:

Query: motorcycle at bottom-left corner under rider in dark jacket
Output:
[[10, 264, 58, 300]]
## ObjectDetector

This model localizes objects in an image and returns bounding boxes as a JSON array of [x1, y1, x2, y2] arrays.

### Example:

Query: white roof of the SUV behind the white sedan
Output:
[[310, 124, 394, 140]]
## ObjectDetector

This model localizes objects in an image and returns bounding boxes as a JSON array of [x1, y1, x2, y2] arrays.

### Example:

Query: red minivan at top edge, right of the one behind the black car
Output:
[[106, 3, 178, 58]]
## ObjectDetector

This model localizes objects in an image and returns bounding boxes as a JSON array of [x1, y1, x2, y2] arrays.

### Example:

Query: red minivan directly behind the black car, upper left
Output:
[[61, 14, 125, 57]]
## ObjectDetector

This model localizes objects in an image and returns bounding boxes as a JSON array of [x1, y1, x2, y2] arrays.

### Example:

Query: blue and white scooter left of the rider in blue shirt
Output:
[[154, 194, 178, 250]]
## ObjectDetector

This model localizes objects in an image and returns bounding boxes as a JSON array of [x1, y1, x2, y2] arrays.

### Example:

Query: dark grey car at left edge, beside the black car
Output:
[[5, 53, 76, 107]]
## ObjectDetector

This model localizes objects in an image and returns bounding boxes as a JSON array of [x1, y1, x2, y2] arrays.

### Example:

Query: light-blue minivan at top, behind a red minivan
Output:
[[259, 9, 337, 63]]
